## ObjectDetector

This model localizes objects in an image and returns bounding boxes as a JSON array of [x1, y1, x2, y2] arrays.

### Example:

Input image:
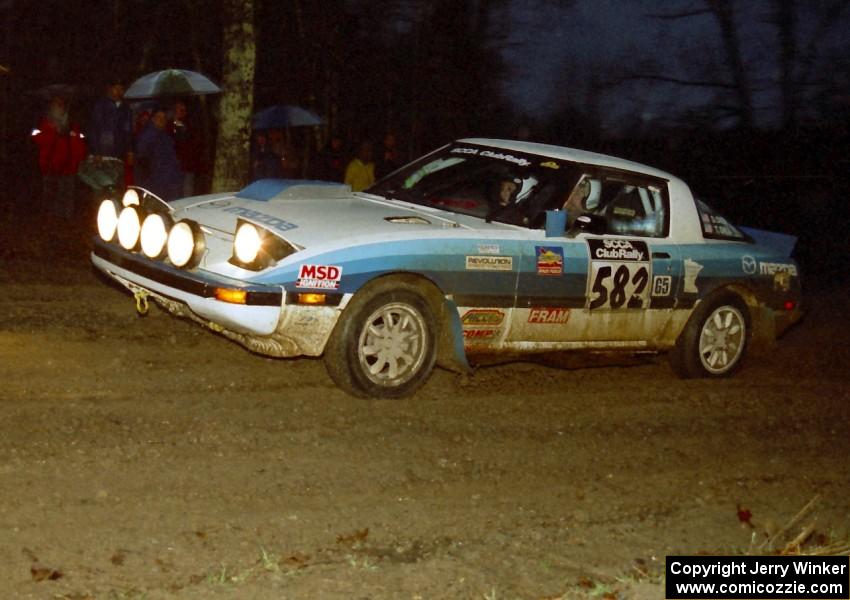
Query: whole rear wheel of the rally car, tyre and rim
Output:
[[670, 294, 749, 377]]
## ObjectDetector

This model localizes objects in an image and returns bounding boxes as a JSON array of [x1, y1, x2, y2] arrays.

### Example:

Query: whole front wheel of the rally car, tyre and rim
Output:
[[325, 286, 436, 398]]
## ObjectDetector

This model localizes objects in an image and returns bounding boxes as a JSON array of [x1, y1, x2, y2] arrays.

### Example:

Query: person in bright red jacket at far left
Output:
[[32, 96, 86, 218]]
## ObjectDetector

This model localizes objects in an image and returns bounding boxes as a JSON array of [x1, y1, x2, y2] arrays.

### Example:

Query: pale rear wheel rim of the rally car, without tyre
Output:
[[699, 306, 747, 375]]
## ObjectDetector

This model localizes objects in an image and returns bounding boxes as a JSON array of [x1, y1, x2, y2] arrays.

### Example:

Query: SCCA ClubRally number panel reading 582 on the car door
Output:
[[587, 239, 652, 310]]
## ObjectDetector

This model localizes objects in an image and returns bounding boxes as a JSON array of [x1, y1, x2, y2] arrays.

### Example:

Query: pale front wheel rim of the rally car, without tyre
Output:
[[357, 302, 428, 387]]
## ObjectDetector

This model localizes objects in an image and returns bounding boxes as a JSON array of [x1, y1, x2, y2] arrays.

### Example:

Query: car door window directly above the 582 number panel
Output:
[[588, 178, 668, 237]]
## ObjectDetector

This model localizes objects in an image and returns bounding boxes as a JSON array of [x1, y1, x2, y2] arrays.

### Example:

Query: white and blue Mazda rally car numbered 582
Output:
[[92, 139, 800, 397]]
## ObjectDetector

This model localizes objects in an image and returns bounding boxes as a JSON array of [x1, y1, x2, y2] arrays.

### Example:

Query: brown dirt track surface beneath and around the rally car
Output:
[[0, 223, 850, 600]]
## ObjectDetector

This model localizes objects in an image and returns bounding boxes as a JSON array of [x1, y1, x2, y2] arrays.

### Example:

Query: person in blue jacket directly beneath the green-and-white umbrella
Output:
[[135, 108, 183, 201]]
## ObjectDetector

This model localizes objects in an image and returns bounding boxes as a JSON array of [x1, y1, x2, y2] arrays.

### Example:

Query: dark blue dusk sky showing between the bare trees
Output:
[[505, 0, 850, 127]]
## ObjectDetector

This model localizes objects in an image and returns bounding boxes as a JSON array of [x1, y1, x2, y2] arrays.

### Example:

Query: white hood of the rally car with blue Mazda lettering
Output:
[[171, 182, 494, 247]]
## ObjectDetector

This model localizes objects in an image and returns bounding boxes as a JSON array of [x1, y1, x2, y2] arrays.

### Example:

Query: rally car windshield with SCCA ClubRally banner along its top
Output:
[[366, 143, 577, 228]]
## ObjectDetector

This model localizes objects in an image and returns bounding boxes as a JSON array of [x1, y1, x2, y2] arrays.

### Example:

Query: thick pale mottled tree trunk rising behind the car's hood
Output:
[[212, 0, 257, 192]]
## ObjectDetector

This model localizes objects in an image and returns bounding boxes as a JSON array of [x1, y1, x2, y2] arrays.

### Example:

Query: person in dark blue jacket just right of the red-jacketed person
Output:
[[88, 80, 133, 183]]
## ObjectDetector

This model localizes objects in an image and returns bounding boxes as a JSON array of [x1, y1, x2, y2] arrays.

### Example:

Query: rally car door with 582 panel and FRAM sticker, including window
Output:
[[509, 169, 681, 349]]
